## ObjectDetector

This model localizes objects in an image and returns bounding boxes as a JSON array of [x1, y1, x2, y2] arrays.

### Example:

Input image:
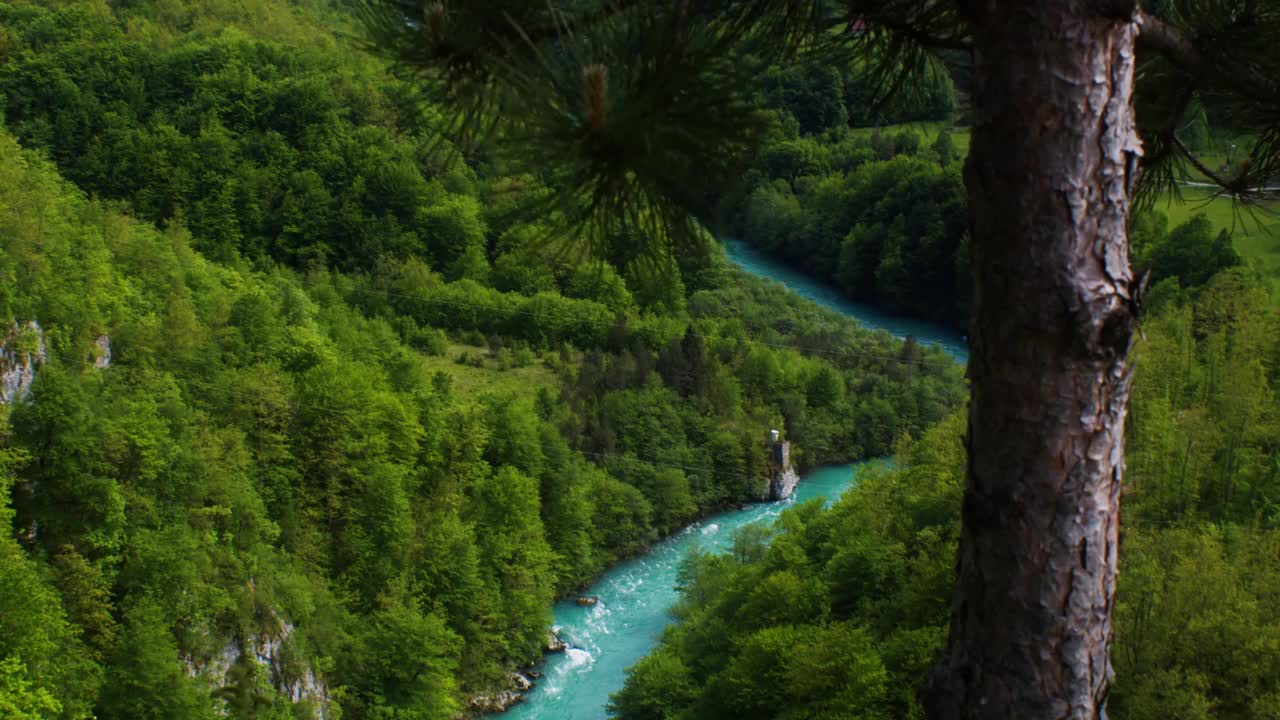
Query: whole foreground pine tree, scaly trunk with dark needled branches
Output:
[[362, 0, 1280, 719]]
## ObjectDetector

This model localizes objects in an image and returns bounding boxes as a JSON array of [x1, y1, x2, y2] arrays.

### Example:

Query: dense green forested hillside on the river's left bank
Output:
[[0, 0, 964, 719]]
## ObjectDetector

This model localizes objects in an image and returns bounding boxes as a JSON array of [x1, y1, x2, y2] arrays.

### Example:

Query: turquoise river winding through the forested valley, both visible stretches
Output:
[[500, 240, 966, 720]]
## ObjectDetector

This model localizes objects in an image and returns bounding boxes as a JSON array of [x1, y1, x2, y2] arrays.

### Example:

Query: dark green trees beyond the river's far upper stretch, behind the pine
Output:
[[718, 60, 1266, 331]]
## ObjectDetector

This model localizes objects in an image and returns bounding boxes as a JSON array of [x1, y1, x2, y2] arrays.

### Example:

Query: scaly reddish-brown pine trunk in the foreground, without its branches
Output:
[[927, 0, 1140, 720]]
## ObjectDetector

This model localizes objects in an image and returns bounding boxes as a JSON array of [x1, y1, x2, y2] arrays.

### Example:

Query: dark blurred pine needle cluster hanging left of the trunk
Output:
[[360, 0, 832, 260]]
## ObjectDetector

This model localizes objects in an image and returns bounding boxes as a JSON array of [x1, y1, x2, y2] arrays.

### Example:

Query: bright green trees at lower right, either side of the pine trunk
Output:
[[613, 260, 1280, 720]]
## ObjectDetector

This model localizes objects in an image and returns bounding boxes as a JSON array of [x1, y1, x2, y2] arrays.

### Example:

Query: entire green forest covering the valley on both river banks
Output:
[[0, 0, 1280, 720]]
